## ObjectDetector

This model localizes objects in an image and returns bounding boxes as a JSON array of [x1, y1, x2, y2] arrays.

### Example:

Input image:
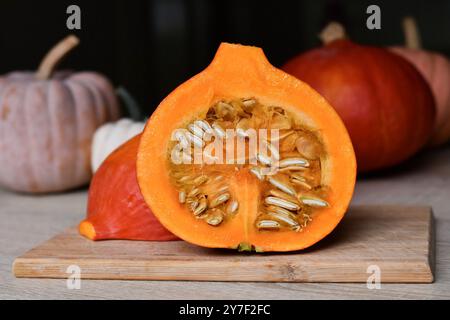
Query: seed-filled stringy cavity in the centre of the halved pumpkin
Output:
[[167, 97, 330, 232]]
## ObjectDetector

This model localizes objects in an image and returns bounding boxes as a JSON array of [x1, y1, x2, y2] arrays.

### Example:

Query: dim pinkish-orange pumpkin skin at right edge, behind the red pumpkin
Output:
[[391, 47, 450, 145]]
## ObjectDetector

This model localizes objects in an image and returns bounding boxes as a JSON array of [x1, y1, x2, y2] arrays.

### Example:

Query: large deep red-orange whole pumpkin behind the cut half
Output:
[[282, 23, 435, 172]]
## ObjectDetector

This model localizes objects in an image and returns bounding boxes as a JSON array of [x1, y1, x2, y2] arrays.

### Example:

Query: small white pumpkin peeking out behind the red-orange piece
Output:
[[91, 118, 145, 172]]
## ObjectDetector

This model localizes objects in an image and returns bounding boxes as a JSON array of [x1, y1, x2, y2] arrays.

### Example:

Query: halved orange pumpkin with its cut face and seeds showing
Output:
[[137, 43, 356, 251]]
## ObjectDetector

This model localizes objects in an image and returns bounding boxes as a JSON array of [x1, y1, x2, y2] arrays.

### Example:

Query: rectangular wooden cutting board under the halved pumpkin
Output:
[[13, 206, 434, 283]]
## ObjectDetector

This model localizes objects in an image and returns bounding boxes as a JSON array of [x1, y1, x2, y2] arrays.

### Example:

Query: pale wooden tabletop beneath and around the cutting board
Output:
[[0, 147, 450, 299]]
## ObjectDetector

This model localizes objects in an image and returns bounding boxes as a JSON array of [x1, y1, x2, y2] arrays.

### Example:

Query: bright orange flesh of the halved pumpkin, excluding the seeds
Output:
[[137, 44, 356, 251]]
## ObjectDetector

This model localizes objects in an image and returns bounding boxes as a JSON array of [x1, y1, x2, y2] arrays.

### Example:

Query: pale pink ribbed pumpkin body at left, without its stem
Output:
[[0, 72, 119, 193]]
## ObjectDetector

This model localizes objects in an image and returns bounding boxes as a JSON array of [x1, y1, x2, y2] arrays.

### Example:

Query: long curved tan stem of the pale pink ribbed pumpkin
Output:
[[36, 35, 80, 80]]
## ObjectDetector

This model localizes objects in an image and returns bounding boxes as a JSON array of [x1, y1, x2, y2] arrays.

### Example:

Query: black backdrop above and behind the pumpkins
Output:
[[0, 0, 450, 115]]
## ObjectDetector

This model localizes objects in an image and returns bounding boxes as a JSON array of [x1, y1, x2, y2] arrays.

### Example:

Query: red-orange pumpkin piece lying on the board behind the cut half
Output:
[[79, 135, 177, 240]]
